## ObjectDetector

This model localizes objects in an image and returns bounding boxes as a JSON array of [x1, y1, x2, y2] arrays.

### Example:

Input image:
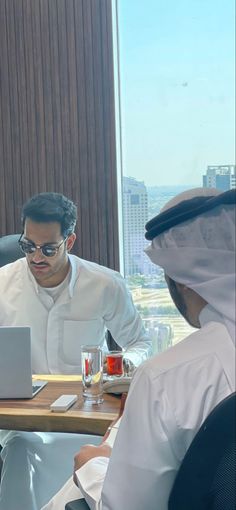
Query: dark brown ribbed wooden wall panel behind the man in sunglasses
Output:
[[0, 0, 119, 269]]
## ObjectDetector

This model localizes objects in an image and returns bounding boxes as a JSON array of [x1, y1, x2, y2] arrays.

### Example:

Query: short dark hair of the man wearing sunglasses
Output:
[[21, 193, 77, 238]]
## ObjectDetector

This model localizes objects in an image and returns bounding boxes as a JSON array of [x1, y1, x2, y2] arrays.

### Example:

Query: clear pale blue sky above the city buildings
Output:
[[118, 0, 235, 186]]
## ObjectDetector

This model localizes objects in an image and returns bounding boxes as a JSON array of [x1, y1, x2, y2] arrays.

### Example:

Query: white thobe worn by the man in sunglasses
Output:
[[0, 255, 151, 510]]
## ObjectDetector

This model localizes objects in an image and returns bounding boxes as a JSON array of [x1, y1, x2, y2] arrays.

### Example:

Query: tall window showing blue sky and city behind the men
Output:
[[113, 0, 235, 352]]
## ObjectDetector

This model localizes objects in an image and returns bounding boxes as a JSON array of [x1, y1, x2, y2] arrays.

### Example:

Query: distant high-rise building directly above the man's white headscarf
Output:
[[203, 165, 236, 191]]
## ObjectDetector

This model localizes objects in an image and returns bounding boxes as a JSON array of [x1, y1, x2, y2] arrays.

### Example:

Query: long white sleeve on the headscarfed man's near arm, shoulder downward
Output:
[[99, 367, 179, 510]]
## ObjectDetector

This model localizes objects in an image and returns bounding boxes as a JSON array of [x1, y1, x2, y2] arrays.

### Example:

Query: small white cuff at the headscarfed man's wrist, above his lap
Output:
[[76, 457, 109, 510]]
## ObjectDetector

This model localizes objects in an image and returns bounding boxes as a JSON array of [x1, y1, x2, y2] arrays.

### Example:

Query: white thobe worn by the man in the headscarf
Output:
[[47, 306, 235, 510]]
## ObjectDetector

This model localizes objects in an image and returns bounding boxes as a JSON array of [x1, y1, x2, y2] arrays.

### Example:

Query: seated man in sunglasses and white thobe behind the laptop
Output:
[[0, 193, 151, 510]]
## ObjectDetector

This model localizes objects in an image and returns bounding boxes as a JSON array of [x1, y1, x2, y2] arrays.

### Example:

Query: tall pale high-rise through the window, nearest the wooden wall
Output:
[[123, 177, 153, 276]]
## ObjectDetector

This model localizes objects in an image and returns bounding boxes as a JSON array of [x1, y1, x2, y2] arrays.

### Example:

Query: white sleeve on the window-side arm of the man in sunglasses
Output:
[[104, 274, 152, 367]]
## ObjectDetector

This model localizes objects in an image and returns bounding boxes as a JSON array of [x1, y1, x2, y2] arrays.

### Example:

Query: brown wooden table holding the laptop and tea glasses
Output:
[[0, 375, 120, 435]]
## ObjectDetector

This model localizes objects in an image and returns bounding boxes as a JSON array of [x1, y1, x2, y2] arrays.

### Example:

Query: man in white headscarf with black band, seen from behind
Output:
[[41, 188, 236, 510]]
